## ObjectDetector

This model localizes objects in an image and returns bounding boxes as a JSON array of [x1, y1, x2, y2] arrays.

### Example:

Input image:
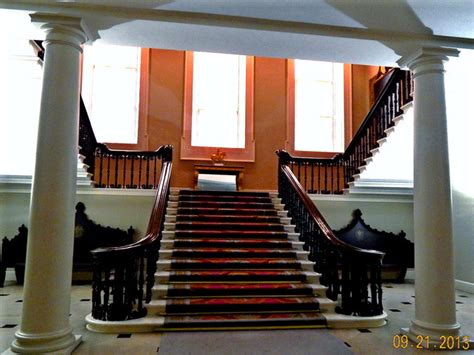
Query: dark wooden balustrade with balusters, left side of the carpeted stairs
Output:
[[91, 145, 173, 321]]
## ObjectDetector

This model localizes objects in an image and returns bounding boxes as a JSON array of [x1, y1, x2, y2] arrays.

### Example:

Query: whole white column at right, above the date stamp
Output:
[[399, 48, 460, 347]]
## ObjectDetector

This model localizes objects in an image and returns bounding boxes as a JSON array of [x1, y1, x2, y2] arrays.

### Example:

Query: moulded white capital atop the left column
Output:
[[30, 13, 92, 52]]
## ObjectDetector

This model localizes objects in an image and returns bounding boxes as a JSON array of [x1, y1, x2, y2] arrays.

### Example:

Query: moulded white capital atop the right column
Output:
[[397, 47, 459, 76]]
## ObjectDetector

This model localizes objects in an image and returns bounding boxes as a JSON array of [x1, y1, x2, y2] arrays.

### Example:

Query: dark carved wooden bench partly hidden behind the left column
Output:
[[0, 202, 135, 287]]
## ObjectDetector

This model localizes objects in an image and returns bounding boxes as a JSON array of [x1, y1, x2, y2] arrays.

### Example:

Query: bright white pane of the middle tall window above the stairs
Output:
[[191, 52, 246, 148]]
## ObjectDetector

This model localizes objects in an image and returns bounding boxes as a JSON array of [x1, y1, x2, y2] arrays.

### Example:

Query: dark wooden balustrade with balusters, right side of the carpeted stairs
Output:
[[277, 151, 384, 316]]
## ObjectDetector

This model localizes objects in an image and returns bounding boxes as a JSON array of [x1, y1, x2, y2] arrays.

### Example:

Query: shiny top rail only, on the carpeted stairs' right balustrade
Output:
[[277, 164, 385, 258]]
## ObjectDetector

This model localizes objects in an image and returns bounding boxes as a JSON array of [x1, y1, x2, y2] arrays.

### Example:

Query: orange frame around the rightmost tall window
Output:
[[285, 59, 352, 158]]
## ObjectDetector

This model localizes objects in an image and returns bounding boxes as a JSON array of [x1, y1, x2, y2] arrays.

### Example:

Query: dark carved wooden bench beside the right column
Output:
[[334, 209, 414, 283]]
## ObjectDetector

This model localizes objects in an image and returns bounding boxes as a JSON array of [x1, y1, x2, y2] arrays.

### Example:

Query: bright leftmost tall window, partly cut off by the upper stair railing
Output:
[[82, 45, 140, 144]]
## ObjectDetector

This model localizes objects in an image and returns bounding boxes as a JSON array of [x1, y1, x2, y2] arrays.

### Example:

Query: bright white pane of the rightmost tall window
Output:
[[294, 60, 344, 152]]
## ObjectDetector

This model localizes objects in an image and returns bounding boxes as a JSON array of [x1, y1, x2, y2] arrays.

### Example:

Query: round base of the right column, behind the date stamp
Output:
[[400, 320, 474, 350]]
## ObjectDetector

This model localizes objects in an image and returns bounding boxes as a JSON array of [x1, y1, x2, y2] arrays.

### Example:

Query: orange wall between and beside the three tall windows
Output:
[[146, 49, 376, 190]]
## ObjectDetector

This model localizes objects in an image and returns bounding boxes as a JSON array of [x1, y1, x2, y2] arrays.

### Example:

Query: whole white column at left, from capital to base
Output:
[[11, 14, 86, 353]]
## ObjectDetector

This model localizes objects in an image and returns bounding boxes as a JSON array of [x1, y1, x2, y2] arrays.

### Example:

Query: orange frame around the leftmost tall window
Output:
[[81, 48, 151, 150]]
